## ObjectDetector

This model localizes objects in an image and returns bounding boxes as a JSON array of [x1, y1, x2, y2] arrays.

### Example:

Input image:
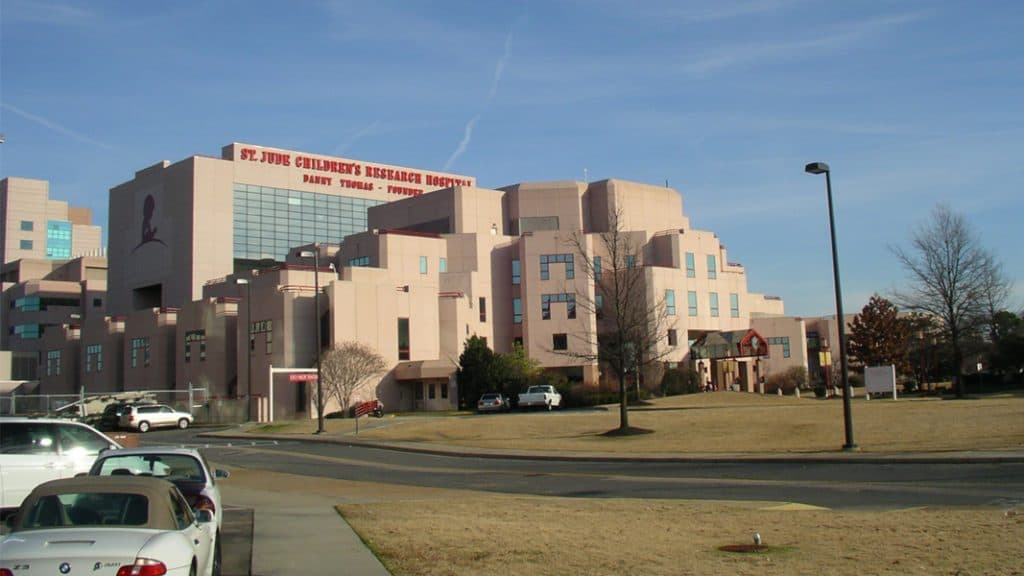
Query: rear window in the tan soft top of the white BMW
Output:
[[16, 492, 150, 530]]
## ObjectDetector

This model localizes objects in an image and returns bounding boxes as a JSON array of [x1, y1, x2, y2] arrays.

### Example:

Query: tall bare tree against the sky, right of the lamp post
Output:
[[891, 204, 1008, 397]]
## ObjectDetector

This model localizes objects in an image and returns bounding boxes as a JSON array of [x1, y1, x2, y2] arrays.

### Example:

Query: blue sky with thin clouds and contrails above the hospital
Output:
[[0, 0, 1024, 316]]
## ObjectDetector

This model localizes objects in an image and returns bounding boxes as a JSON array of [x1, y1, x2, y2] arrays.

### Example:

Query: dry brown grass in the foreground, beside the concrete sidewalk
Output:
[[339, 495, 1024, 576]]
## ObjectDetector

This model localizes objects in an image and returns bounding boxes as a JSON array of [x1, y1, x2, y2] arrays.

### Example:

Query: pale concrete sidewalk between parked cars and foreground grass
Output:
[[220, 482, 390, 576]]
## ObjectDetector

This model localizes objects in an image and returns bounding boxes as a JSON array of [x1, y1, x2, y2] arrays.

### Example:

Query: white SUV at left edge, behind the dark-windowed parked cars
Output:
[[0, 416, 121, 513]]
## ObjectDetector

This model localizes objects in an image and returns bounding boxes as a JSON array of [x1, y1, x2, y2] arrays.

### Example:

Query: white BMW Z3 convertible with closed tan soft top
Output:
[[0, 477, 216, 576]]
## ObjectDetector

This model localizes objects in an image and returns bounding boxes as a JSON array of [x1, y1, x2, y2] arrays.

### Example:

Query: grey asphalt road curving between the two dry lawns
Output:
[[143, 424, 1024, 509]]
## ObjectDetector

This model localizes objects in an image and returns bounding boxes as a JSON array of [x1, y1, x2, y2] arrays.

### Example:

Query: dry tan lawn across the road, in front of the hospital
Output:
[[264, 392, 1024, 454]]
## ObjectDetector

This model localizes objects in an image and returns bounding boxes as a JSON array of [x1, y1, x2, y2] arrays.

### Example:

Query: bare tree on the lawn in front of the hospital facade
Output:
[[566, 208, 670, 433]]
